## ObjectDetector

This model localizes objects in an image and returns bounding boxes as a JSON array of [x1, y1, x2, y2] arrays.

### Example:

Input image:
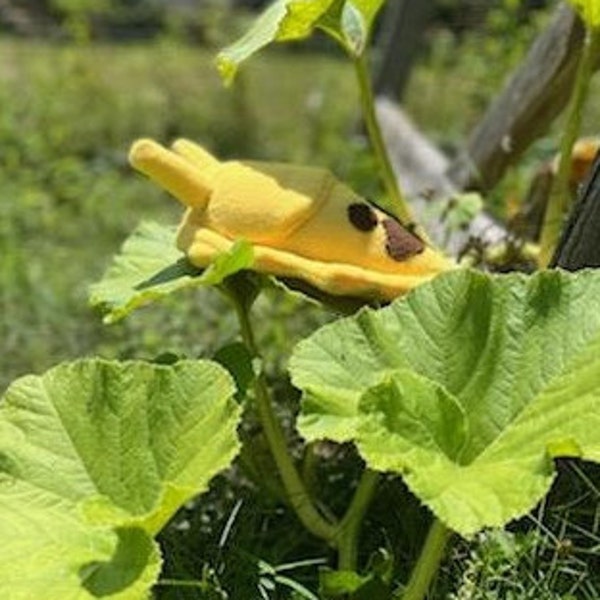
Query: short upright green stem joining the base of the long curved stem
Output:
[[337, 469, 379, 571]]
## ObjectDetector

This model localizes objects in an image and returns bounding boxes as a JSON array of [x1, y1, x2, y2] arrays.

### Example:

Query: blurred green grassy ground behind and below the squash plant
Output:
[[0, 8, 600, 600]]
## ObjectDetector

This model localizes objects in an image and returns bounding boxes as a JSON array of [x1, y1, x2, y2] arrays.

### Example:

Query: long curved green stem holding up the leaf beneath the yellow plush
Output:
[[229, 294, 337, 546]]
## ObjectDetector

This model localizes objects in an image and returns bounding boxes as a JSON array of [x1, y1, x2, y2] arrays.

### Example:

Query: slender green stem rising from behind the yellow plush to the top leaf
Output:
[[352, 52, 413, 223]]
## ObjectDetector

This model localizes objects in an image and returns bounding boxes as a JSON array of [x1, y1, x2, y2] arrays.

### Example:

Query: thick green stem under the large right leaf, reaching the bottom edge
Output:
[[393, 519, 452, 600]]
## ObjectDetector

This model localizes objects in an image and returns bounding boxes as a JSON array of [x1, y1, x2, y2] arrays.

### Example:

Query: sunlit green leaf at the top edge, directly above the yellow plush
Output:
[[216, 0, 384, 83]]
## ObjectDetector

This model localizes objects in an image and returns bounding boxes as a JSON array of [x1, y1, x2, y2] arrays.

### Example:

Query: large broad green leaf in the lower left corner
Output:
[[0, 360, 239, 600]]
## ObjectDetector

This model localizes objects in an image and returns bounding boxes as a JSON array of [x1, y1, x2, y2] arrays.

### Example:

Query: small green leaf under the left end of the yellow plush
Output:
[[90, 223, 253, 323]]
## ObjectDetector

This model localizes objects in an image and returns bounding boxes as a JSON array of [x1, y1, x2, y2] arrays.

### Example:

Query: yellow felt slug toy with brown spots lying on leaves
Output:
[[130, 139, 453, 300]]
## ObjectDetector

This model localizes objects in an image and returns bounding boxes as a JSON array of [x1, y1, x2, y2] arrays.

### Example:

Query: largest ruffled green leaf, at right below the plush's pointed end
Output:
[[291, 270, 600, 535]]
